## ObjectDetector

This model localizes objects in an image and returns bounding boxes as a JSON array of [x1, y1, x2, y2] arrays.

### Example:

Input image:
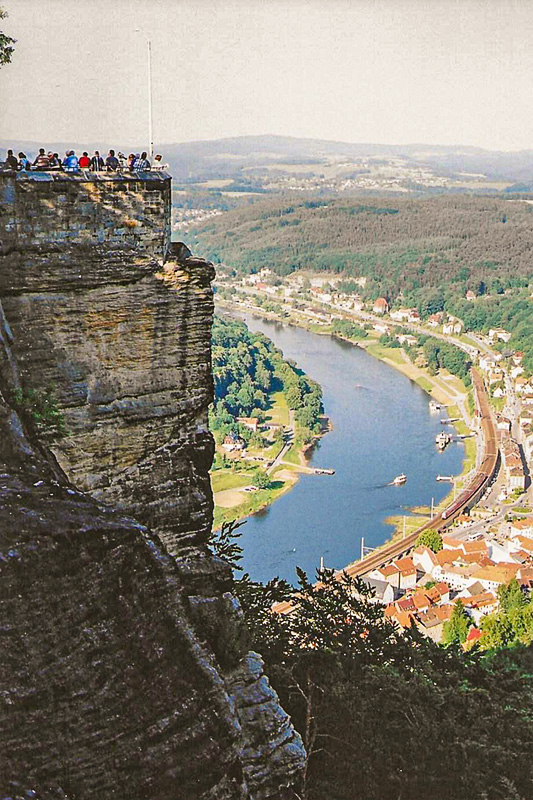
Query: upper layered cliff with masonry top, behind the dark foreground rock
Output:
[[0, 173, 214, 553]]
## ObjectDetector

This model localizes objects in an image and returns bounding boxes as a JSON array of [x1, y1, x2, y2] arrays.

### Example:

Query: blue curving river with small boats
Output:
[[231, 314, 464, 583]]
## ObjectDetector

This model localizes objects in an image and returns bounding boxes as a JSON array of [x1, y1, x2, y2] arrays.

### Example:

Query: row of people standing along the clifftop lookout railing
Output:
[[0, 147, 168, 172]]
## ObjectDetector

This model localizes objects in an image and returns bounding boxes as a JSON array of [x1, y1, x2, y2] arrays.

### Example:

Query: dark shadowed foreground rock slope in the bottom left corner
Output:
[[0, 416, 249, 800]]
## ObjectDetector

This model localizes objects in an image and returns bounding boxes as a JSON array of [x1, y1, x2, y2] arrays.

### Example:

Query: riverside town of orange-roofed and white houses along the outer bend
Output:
[[218, 265, 533, 647]]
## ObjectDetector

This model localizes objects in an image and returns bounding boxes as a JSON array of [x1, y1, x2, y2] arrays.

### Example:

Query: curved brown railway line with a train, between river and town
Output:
[[273, 368, 499, 614]]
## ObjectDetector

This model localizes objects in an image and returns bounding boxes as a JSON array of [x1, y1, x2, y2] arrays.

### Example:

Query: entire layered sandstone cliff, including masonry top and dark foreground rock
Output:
[[0, 173, 304, 800]]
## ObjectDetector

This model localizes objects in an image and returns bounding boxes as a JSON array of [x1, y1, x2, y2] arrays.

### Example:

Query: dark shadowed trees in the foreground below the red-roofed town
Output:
[[212, 526, 533, 800]]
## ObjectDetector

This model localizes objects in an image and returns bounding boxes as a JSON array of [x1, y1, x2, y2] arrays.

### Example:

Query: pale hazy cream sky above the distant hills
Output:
[[0, 0, 533, 150]]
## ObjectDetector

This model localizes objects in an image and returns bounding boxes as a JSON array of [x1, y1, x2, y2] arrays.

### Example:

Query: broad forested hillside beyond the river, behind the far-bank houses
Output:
[[194, 195, 533, 374]]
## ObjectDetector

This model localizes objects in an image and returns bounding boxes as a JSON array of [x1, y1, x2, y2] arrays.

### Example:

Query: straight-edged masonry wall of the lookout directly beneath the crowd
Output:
[[0, 169, 172, 268]]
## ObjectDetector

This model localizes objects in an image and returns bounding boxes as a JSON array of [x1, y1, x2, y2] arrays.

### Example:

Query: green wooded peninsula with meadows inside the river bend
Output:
[[210, 316, 331, 527]]
